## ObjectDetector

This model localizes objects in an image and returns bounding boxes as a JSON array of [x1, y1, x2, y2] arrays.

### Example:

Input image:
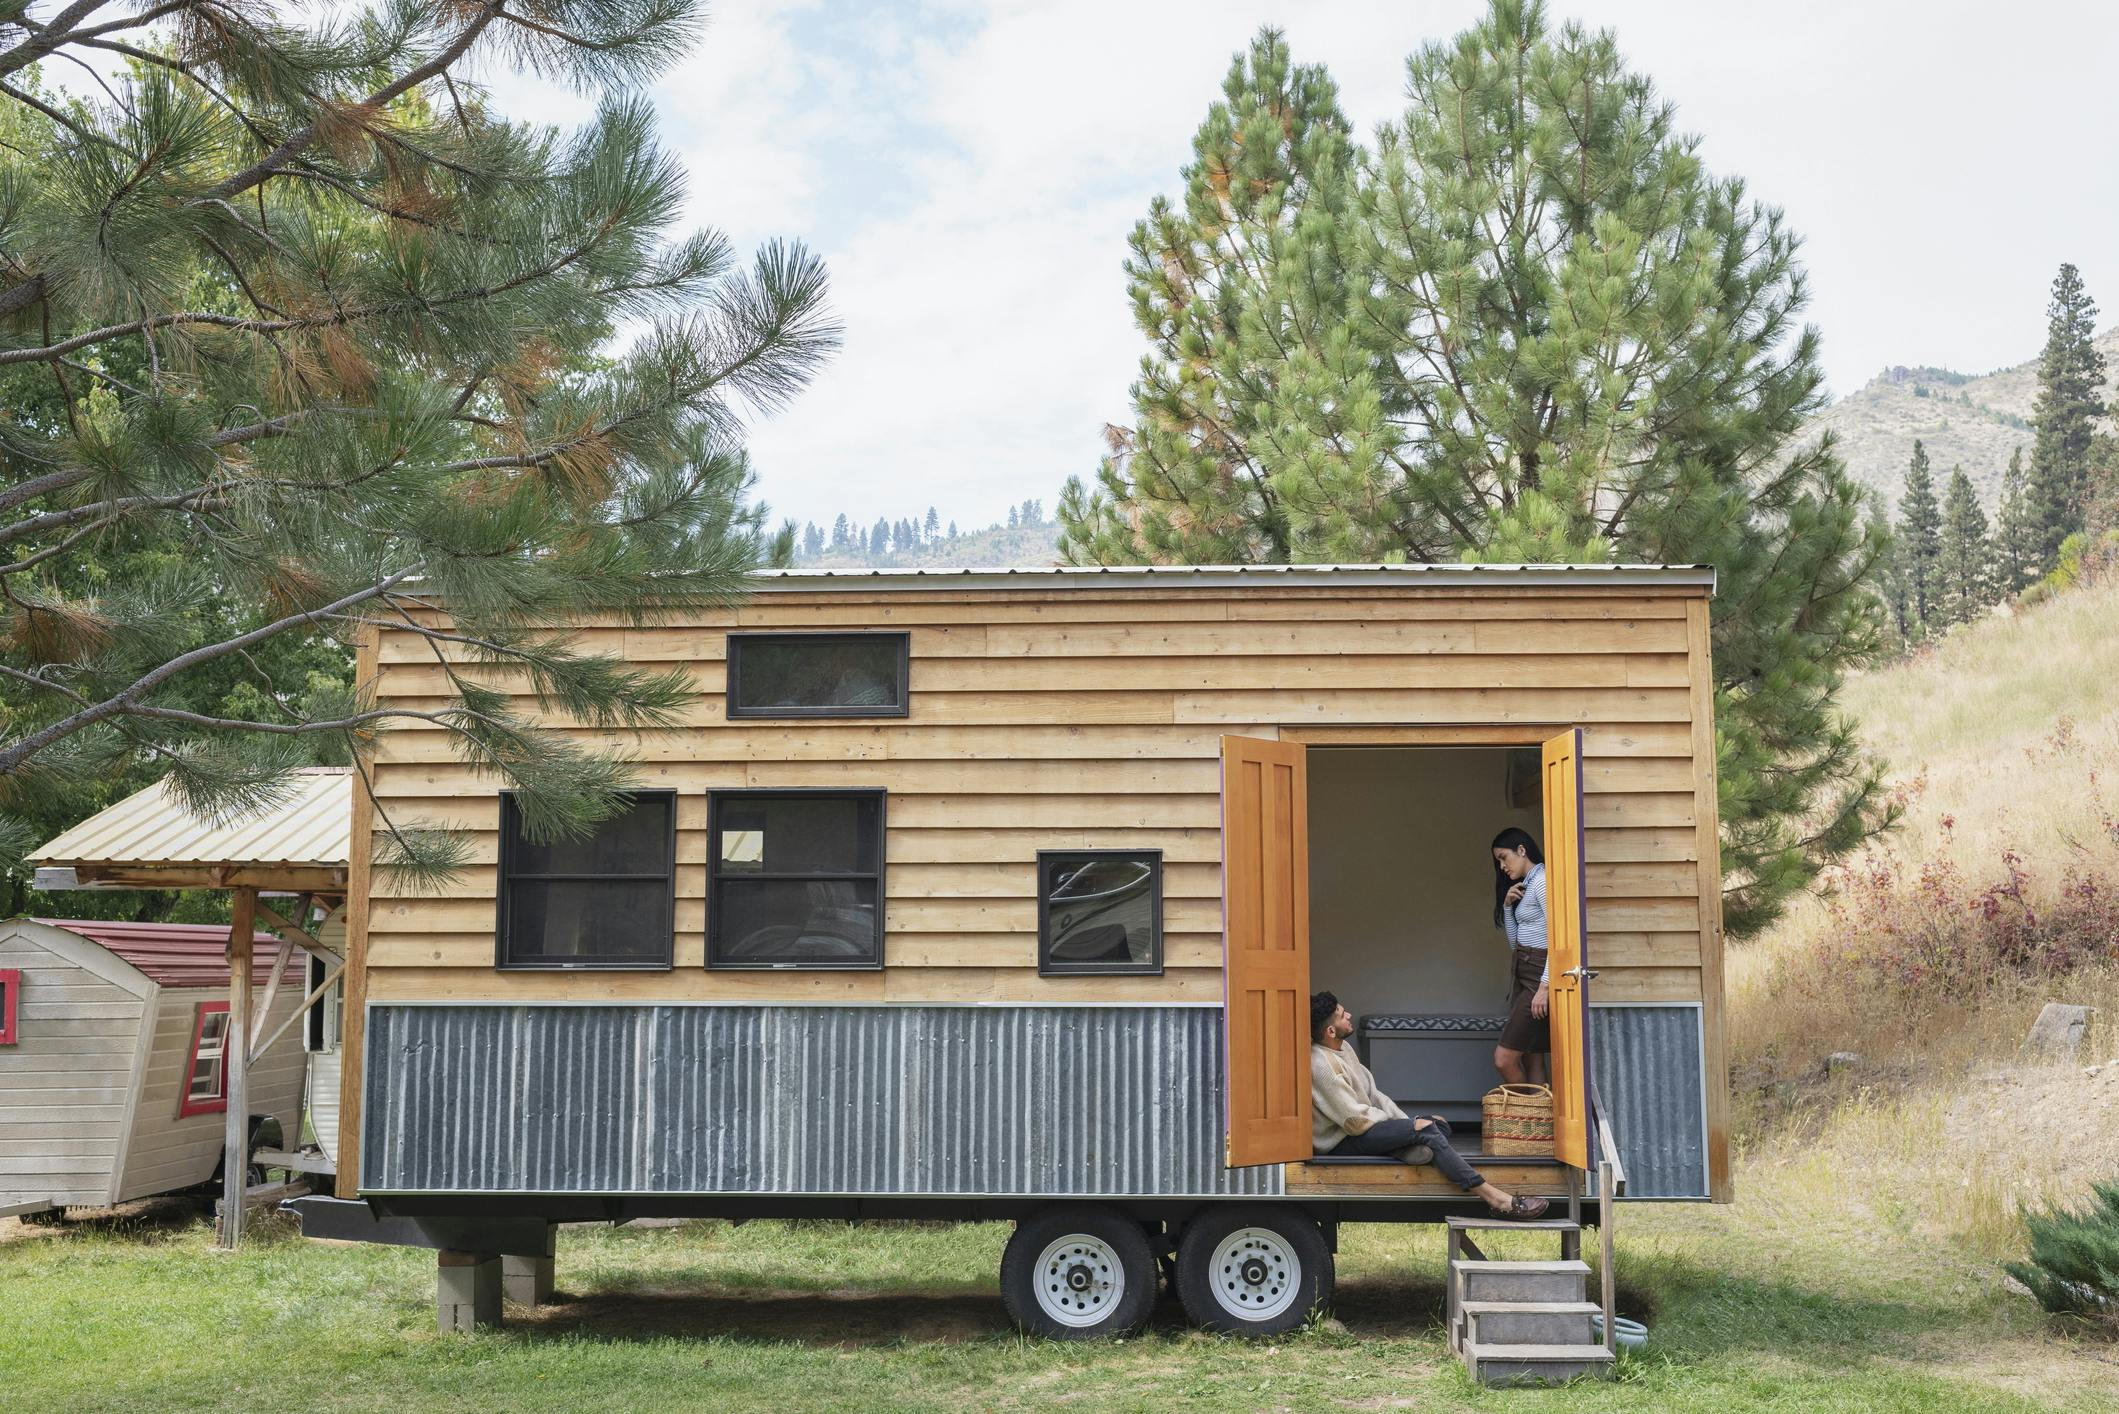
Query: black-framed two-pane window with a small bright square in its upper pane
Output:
[[706, 791, 884, 967]]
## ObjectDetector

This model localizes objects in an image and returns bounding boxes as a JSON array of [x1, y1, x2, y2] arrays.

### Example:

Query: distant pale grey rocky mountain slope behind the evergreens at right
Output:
[[1808, 329, 2119, 517]]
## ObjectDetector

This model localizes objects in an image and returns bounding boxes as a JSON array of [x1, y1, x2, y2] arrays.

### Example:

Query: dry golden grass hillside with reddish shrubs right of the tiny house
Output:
[[1729, 568, 2119, 1257]]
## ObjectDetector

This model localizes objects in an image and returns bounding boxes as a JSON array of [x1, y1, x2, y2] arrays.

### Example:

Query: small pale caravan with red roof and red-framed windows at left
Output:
[[0, 918, 305, 1213]]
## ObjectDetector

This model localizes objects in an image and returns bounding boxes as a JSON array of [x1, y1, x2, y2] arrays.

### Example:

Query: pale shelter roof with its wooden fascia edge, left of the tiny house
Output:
[[30, 765, 354, 888]]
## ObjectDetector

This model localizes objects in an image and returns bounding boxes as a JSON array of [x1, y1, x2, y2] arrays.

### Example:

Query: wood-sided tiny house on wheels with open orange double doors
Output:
[[299, 566, 1729, 1333]]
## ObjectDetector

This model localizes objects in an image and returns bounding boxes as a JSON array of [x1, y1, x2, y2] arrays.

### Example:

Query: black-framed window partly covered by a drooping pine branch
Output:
[[494, 791, 676, 967]]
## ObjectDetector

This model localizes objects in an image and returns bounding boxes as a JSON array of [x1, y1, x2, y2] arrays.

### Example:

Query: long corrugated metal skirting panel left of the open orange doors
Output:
[[362, 1005, 1280, 1196]]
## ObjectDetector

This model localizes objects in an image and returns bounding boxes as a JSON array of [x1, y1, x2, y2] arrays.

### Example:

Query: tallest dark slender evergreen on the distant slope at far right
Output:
[[2030, 265, 2104, 570]]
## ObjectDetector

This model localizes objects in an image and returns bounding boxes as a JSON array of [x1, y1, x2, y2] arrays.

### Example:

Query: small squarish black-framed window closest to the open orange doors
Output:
[[1038, 850, 1163, 977]]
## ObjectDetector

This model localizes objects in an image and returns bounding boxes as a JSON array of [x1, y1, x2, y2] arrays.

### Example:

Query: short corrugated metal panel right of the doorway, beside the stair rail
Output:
[[1589, 1007, 1708, 1198]]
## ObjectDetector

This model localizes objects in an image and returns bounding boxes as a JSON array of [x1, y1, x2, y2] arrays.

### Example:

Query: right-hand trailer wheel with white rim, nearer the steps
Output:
[[1178, 1204, 1333, 1336]]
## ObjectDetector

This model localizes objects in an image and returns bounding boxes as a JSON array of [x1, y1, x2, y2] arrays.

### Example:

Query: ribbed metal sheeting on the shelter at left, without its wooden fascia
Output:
[[30, 765, 354, 867]]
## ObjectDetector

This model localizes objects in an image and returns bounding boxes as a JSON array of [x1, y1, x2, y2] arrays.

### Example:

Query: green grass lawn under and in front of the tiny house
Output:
[[0, 1168, 2119, 1414]]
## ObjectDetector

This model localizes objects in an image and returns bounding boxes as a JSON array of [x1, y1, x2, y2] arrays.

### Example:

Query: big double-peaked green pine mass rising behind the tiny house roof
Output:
[[1060, 13, 1888, 933]]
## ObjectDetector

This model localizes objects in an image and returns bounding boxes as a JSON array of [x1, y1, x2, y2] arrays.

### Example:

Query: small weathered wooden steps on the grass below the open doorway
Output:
[[1447, 1217, 1615, 1384]]
